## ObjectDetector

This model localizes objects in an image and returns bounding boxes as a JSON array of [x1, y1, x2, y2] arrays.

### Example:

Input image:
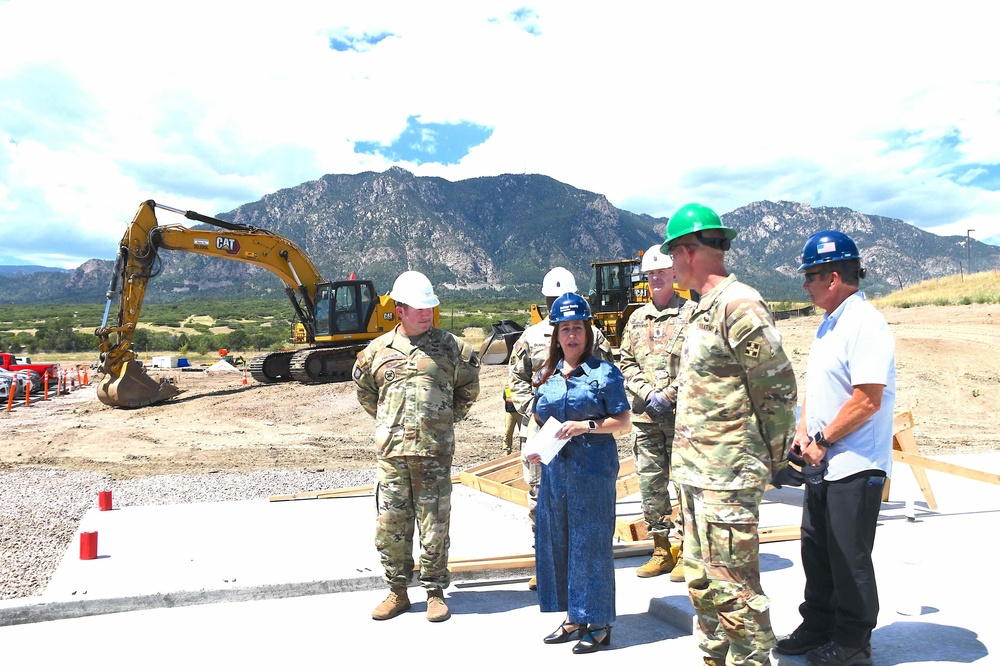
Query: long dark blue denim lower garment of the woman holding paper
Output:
[[535, 436, 618, 624]]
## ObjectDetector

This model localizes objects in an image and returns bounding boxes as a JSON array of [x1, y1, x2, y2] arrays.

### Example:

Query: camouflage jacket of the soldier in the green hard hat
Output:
[[673, 275, 797, 490]]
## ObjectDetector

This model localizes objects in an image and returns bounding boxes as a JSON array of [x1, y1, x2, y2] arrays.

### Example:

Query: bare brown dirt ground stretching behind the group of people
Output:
[[0, 305, 1000, 479]]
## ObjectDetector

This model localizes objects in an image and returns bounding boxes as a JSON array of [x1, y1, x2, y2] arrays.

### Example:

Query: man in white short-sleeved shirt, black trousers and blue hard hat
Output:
[[774, 231, 896, 666]]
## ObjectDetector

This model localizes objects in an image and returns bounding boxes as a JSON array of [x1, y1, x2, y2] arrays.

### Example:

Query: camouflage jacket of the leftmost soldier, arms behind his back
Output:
[[354, 326, 479, 458]]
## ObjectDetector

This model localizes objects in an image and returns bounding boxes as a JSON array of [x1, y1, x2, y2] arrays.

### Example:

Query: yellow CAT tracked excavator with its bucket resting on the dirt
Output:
[[94, 201, 440, 407]]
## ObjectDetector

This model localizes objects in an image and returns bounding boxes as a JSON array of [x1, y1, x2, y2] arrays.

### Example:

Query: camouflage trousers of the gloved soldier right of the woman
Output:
[[632, 421, 684, 545]]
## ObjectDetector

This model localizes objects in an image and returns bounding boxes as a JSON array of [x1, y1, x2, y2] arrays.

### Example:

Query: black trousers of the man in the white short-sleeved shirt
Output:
[[799, 470, 885, 648]]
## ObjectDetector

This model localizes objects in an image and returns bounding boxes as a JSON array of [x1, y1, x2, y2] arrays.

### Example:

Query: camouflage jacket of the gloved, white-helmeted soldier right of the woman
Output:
[[618, 294, 696, 423]]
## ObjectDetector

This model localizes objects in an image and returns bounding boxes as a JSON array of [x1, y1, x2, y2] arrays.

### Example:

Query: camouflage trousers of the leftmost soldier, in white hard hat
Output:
[[375, 456, 451, 589]]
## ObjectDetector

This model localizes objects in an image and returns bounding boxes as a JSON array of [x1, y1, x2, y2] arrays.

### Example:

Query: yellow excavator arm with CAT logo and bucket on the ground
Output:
[[94, 201, 324, 407]]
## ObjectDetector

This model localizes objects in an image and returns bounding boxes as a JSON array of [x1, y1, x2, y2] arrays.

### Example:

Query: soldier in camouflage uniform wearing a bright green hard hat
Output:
[[662, 204, 796, 666]]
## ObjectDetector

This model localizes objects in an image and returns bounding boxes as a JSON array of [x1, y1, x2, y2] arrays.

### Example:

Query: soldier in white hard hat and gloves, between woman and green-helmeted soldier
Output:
[[618, 245, 695, 582]]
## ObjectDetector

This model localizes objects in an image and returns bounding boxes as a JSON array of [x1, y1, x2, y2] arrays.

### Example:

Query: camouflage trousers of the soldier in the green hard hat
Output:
[[681, 485, 775, 666]]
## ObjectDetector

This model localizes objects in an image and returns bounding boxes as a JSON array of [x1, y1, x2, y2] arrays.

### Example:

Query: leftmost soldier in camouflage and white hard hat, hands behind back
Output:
[[354, 271, 479, 622]]
